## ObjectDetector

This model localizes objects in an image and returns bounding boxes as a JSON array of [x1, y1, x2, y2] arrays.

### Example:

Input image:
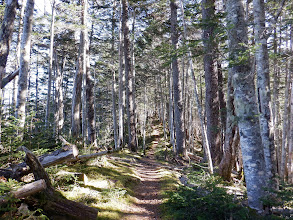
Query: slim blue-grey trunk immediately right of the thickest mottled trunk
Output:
[[253, 0, 276, 185]]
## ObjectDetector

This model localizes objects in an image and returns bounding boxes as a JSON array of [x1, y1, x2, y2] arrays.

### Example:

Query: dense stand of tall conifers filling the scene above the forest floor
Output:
[[0, 0, 293, 217]]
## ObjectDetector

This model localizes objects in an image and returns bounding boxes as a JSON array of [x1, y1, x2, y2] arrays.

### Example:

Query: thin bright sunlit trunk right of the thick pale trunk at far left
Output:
[[45, 0, 55, 128]]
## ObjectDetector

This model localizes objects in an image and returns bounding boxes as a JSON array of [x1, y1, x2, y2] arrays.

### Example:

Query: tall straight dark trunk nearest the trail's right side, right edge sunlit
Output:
[[170, 0, 185, 155]]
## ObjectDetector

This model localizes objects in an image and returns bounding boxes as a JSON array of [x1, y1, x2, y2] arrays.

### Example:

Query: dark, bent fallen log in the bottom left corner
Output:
[[22, 147, 98, 220]]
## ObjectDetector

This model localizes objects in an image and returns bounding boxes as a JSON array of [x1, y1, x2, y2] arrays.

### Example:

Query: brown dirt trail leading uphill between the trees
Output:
[[122, 129, 162, 220]]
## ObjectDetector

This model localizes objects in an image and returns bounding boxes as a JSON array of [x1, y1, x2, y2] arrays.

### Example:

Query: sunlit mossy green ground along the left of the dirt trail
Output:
[[51, 151, 139, 219]]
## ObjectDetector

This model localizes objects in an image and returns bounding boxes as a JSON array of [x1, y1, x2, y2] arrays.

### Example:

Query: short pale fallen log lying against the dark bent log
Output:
[[0, 179, 47, 205]]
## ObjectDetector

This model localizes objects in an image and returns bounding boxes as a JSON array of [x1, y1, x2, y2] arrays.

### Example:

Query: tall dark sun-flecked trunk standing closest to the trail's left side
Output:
[[122, 0, 137, 151]]
